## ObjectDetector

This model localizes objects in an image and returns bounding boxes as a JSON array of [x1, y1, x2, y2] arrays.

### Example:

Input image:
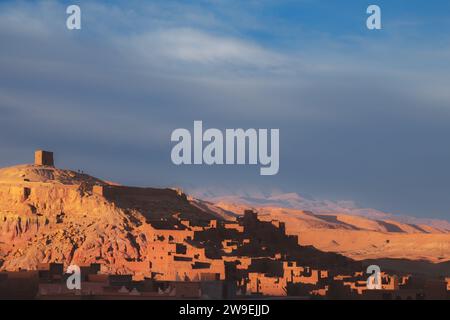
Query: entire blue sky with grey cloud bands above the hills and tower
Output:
[[0, 0, 450, 219]]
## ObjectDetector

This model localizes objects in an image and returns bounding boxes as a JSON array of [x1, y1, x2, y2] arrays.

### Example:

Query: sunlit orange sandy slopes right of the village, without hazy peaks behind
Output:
[[216, 202, 450, 262]]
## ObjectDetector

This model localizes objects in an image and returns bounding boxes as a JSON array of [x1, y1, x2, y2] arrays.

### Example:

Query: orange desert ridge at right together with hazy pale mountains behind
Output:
[[209, 194, 450, 263]]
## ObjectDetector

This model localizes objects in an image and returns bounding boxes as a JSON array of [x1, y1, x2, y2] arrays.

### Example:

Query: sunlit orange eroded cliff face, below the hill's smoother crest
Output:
[[0, 185, 146, 271]]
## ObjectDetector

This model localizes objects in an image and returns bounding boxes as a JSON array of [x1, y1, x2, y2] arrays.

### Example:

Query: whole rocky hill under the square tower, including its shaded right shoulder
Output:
[[0, 165, 221, 274]]
